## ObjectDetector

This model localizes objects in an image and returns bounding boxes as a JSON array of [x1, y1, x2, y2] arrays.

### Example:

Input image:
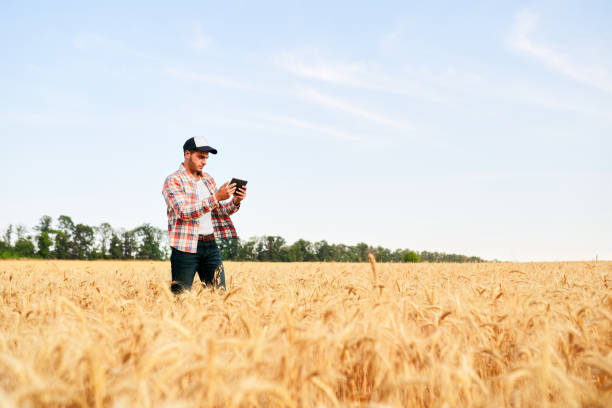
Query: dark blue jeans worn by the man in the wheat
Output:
[[170, 241, 225, 293]]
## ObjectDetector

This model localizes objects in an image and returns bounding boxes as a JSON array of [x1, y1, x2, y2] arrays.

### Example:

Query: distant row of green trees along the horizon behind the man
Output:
[[0, 215, 483, 262]]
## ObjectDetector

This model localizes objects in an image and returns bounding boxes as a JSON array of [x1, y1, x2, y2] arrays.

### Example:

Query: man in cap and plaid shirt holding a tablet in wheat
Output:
[[162, 137, 246, 293]]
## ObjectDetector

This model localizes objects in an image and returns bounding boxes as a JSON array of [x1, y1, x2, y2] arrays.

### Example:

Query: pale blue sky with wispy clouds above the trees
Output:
[[0, 0, 612, 261]]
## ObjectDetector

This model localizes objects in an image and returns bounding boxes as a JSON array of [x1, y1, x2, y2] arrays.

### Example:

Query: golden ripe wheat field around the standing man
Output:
[[0, 260, 612, 407]]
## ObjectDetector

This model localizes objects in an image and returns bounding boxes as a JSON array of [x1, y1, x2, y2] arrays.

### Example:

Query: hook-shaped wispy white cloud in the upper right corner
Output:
[[509, 12, 612, 93]]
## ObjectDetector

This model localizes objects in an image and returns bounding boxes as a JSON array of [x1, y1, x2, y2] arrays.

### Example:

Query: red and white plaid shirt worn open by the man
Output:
[[162, 164, 240, 253]]
